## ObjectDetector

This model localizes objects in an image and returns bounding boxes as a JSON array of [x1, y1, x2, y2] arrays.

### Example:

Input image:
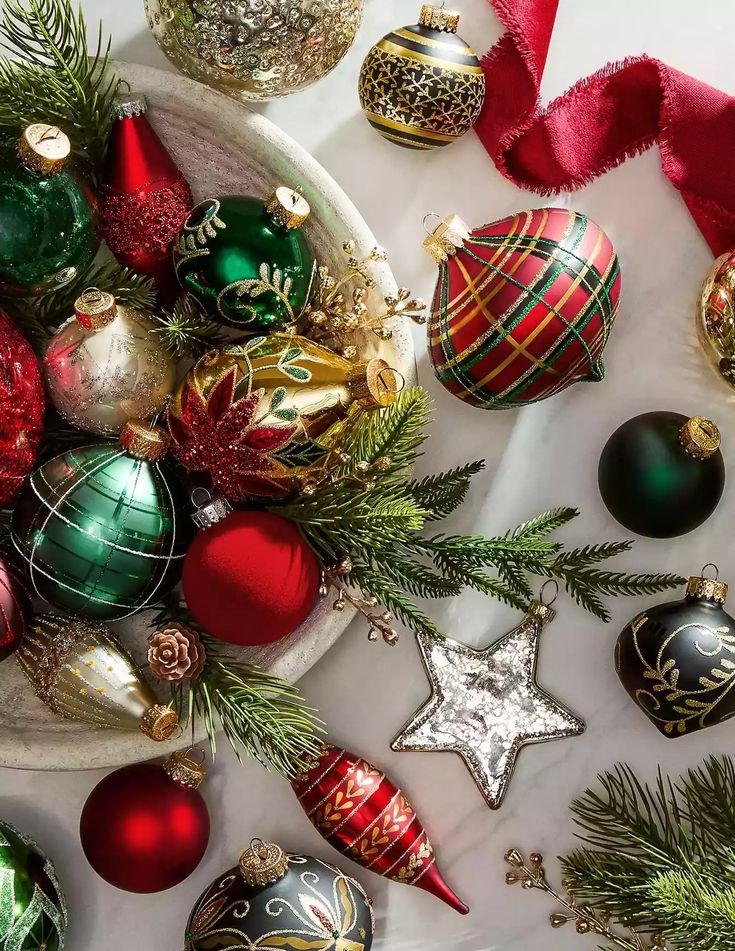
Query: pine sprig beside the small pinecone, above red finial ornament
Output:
[[153, 595, 324, 778]]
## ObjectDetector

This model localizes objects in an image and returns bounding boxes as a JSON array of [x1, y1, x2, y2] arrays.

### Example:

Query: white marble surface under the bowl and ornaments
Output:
[[0, 0, 735, 951]]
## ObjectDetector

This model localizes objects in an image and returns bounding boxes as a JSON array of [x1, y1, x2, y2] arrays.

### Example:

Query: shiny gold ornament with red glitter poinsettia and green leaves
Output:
[[168, 334, 398, 501]]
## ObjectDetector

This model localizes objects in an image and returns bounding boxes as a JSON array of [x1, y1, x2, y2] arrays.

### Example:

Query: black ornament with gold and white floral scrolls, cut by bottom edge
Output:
[[184, 839, 375, 951]]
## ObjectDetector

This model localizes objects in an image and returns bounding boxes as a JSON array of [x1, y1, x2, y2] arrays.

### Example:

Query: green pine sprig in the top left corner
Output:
[[0, 0, 117, 170]]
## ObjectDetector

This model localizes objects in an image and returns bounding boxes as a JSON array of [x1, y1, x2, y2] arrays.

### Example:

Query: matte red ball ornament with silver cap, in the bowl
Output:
[[183, 496, 321, 647]]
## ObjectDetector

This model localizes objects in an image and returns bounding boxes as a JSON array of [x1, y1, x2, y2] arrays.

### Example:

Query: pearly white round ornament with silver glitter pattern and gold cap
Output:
[[43, 288, 176, 436]]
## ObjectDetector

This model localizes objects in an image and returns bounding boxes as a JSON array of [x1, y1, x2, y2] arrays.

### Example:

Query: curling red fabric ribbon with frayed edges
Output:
[[476, 0, 735, 254]]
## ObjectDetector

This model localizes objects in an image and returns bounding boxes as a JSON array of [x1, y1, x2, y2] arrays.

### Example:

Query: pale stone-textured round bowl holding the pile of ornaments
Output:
[[0, 63, 415, 770]]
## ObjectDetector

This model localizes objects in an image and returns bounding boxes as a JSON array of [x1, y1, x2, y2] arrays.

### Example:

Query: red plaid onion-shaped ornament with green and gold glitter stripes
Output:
[[424, 208, 620, 409]]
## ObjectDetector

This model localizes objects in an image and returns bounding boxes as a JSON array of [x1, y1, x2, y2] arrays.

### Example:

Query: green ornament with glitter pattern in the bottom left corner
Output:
[[0, 821, 67, 951]]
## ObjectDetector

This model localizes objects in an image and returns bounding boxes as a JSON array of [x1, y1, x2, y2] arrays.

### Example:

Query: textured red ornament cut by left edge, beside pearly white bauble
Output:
[[0, 311, 46, 505]]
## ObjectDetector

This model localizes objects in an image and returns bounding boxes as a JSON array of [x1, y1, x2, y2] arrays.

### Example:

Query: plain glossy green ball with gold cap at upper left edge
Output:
[[0, 124, 99, 296]]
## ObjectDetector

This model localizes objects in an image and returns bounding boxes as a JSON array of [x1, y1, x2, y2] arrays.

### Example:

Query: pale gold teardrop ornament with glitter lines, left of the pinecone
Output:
[[16, 614, 179, 742]]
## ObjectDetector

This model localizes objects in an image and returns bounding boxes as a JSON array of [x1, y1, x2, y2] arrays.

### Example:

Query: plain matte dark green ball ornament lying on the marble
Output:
[[598, 412, 725, 538]]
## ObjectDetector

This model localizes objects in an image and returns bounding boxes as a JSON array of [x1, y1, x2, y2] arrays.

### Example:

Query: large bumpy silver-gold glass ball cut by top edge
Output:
[[145, 0, 363, 100]]
